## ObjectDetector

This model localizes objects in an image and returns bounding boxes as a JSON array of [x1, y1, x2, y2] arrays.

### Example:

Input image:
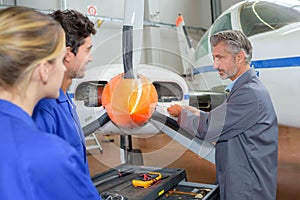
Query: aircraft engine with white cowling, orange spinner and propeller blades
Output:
[[69, 0, 218, 165]]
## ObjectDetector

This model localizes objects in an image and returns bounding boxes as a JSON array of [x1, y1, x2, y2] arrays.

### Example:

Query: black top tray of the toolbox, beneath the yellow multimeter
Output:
[[92, 164, 186, 200]]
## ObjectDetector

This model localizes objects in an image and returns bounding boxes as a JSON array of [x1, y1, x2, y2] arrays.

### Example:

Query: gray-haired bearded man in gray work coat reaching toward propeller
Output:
[[168, 30, 278, 200]]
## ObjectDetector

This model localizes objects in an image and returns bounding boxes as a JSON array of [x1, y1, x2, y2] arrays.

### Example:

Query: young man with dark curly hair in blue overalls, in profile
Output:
[[33, 10, 96, 174]]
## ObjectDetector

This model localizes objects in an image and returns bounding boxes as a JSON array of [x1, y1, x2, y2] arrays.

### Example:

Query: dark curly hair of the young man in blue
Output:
[[50, 10, 96, 55]]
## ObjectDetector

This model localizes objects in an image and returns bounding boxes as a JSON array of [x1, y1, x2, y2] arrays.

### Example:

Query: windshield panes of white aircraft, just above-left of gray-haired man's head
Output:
[[195, 13, 232, 60]]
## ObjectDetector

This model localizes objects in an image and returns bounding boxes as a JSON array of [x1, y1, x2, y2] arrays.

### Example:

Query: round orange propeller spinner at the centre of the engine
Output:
[[102, 73, 158, 128]]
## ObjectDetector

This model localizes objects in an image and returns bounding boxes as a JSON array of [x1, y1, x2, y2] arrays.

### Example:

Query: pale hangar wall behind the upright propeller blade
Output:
[[0, 0, 239, 73]]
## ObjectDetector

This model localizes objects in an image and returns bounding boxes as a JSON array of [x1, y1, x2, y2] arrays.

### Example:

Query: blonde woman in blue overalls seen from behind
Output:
[[0, 7, 100, 200]]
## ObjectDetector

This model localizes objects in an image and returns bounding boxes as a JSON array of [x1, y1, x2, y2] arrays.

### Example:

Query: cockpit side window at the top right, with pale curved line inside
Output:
[[240, 1, 300, 37]]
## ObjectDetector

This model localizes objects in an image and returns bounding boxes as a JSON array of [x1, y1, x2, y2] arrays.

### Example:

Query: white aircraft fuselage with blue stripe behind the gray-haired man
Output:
[[177, 0, 300, 127]]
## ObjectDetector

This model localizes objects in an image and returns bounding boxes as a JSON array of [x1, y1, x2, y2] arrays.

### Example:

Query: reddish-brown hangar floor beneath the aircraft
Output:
[[88, 126, 300, 200]]
